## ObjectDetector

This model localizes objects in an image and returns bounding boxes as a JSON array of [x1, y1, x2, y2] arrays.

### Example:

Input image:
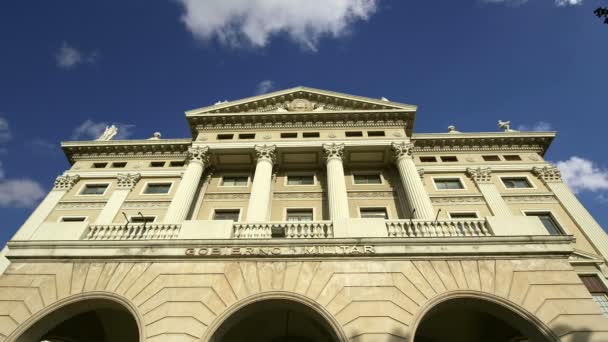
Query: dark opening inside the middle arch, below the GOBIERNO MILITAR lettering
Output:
[[211, 299, 340, 342]]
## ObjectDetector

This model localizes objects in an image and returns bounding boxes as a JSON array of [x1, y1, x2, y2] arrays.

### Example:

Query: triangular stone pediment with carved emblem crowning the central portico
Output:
[[186, 87, 416, 116]]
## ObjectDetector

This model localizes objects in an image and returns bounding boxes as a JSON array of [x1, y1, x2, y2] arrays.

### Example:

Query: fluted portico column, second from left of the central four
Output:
[[246, 145, 276, 222]]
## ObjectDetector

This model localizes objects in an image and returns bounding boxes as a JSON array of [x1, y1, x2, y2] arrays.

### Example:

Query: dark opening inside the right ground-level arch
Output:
[[414, 297, 552, 342]]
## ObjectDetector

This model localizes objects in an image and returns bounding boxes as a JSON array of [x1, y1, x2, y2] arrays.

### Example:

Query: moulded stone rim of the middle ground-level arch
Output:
[[201, 291, 348, 342]]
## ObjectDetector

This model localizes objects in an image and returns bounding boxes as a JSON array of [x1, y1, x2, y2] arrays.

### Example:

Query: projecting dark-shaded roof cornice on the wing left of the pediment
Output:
[[61, 139, 192, 164]]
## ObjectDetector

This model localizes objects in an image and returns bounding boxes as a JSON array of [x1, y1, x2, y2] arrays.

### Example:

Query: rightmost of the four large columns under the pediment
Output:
[[391, 142, 434, 220]]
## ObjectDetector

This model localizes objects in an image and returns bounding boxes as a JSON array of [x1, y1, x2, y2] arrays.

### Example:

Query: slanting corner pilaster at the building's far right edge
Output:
[[532, 166, 608, 260]]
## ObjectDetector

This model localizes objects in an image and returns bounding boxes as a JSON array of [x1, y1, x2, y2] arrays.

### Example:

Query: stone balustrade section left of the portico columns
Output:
[[83, 223, 181, 240]]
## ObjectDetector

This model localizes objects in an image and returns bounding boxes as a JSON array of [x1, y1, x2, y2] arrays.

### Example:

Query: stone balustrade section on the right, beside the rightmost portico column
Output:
[[386, 219, 494, 237]]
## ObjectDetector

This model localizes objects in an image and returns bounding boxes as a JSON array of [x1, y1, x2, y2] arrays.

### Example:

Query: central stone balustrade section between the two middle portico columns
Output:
[[233, 221, 334, 239]]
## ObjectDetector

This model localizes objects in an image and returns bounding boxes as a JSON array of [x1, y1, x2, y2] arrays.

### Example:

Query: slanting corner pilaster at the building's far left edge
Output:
[[13, 175, 80, 240]]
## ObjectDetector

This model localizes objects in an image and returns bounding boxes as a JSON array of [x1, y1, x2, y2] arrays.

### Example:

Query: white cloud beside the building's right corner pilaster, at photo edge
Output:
[[556, 156, 608, 193]]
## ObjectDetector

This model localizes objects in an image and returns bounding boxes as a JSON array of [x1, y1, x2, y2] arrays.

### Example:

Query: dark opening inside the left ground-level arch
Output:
[[16, 298, 140, 342]]
